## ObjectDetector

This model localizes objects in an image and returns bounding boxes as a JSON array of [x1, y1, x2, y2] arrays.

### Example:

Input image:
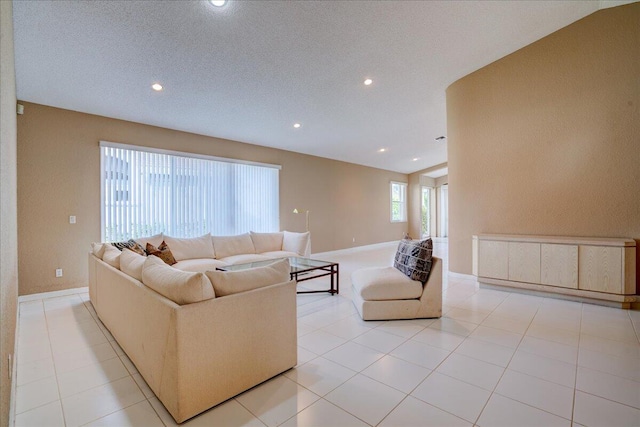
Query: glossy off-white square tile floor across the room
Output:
[[15, 242, 640, 427]]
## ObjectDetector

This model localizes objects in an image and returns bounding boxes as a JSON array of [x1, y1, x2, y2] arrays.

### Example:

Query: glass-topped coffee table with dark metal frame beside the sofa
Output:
[[217, 257, 340, 295]]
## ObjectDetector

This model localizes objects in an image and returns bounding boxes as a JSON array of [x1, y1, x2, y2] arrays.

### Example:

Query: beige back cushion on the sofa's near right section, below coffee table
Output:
[[206, 259, 290, 297]]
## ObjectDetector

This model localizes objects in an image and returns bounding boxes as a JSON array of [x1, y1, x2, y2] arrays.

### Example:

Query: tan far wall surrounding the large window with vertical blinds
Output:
[[18, 103, 407, 295]]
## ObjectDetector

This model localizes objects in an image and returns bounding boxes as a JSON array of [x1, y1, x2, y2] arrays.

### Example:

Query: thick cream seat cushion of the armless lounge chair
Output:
[[351, 267, 423, 301]]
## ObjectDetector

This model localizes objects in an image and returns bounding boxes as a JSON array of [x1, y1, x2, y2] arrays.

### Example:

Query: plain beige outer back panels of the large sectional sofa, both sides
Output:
[[89, 254, 297, 423]]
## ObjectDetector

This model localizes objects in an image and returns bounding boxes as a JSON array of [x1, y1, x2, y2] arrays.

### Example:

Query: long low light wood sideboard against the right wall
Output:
[[473, 234, 640, 308]]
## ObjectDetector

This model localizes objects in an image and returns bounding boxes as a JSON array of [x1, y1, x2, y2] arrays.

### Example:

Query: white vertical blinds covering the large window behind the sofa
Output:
[[100, 142, 280, 242]]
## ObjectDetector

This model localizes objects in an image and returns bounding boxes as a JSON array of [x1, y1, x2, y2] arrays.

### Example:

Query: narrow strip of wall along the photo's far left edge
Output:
[[0, 1, 18, 426]]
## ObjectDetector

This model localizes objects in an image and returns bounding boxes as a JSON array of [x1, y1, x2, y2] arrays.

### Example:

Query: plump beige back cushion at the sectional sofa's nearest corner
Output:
[[142, 256, 215, 305]]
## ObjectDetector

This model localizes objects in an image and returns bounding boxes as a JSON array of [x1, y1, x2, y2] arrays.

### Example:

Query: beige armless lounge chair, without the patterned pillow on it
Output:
[[351, 257, 442, 320]]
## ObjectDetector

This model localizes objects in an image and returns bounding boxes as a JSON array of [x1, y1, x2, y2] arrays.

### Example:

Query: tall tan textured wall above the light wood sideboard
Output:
[[447, 3, 640, 284]]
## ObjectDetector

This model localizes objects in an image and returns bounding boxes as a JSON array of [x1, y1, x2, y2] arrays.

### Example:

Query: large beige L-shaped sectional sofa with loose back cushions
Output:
[[89, 232, 309, 423]]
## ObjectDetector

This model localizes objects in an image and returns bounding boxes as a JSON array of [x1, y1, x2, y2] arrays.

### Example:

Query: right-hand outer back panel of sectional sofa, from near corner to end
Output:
[[169, 281, 298, 422]]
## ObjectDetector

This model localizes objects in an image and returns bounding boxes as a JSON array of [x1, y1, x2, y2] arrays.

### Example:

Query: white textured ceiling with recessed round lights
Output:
[[13, 0, 624, 173]]
